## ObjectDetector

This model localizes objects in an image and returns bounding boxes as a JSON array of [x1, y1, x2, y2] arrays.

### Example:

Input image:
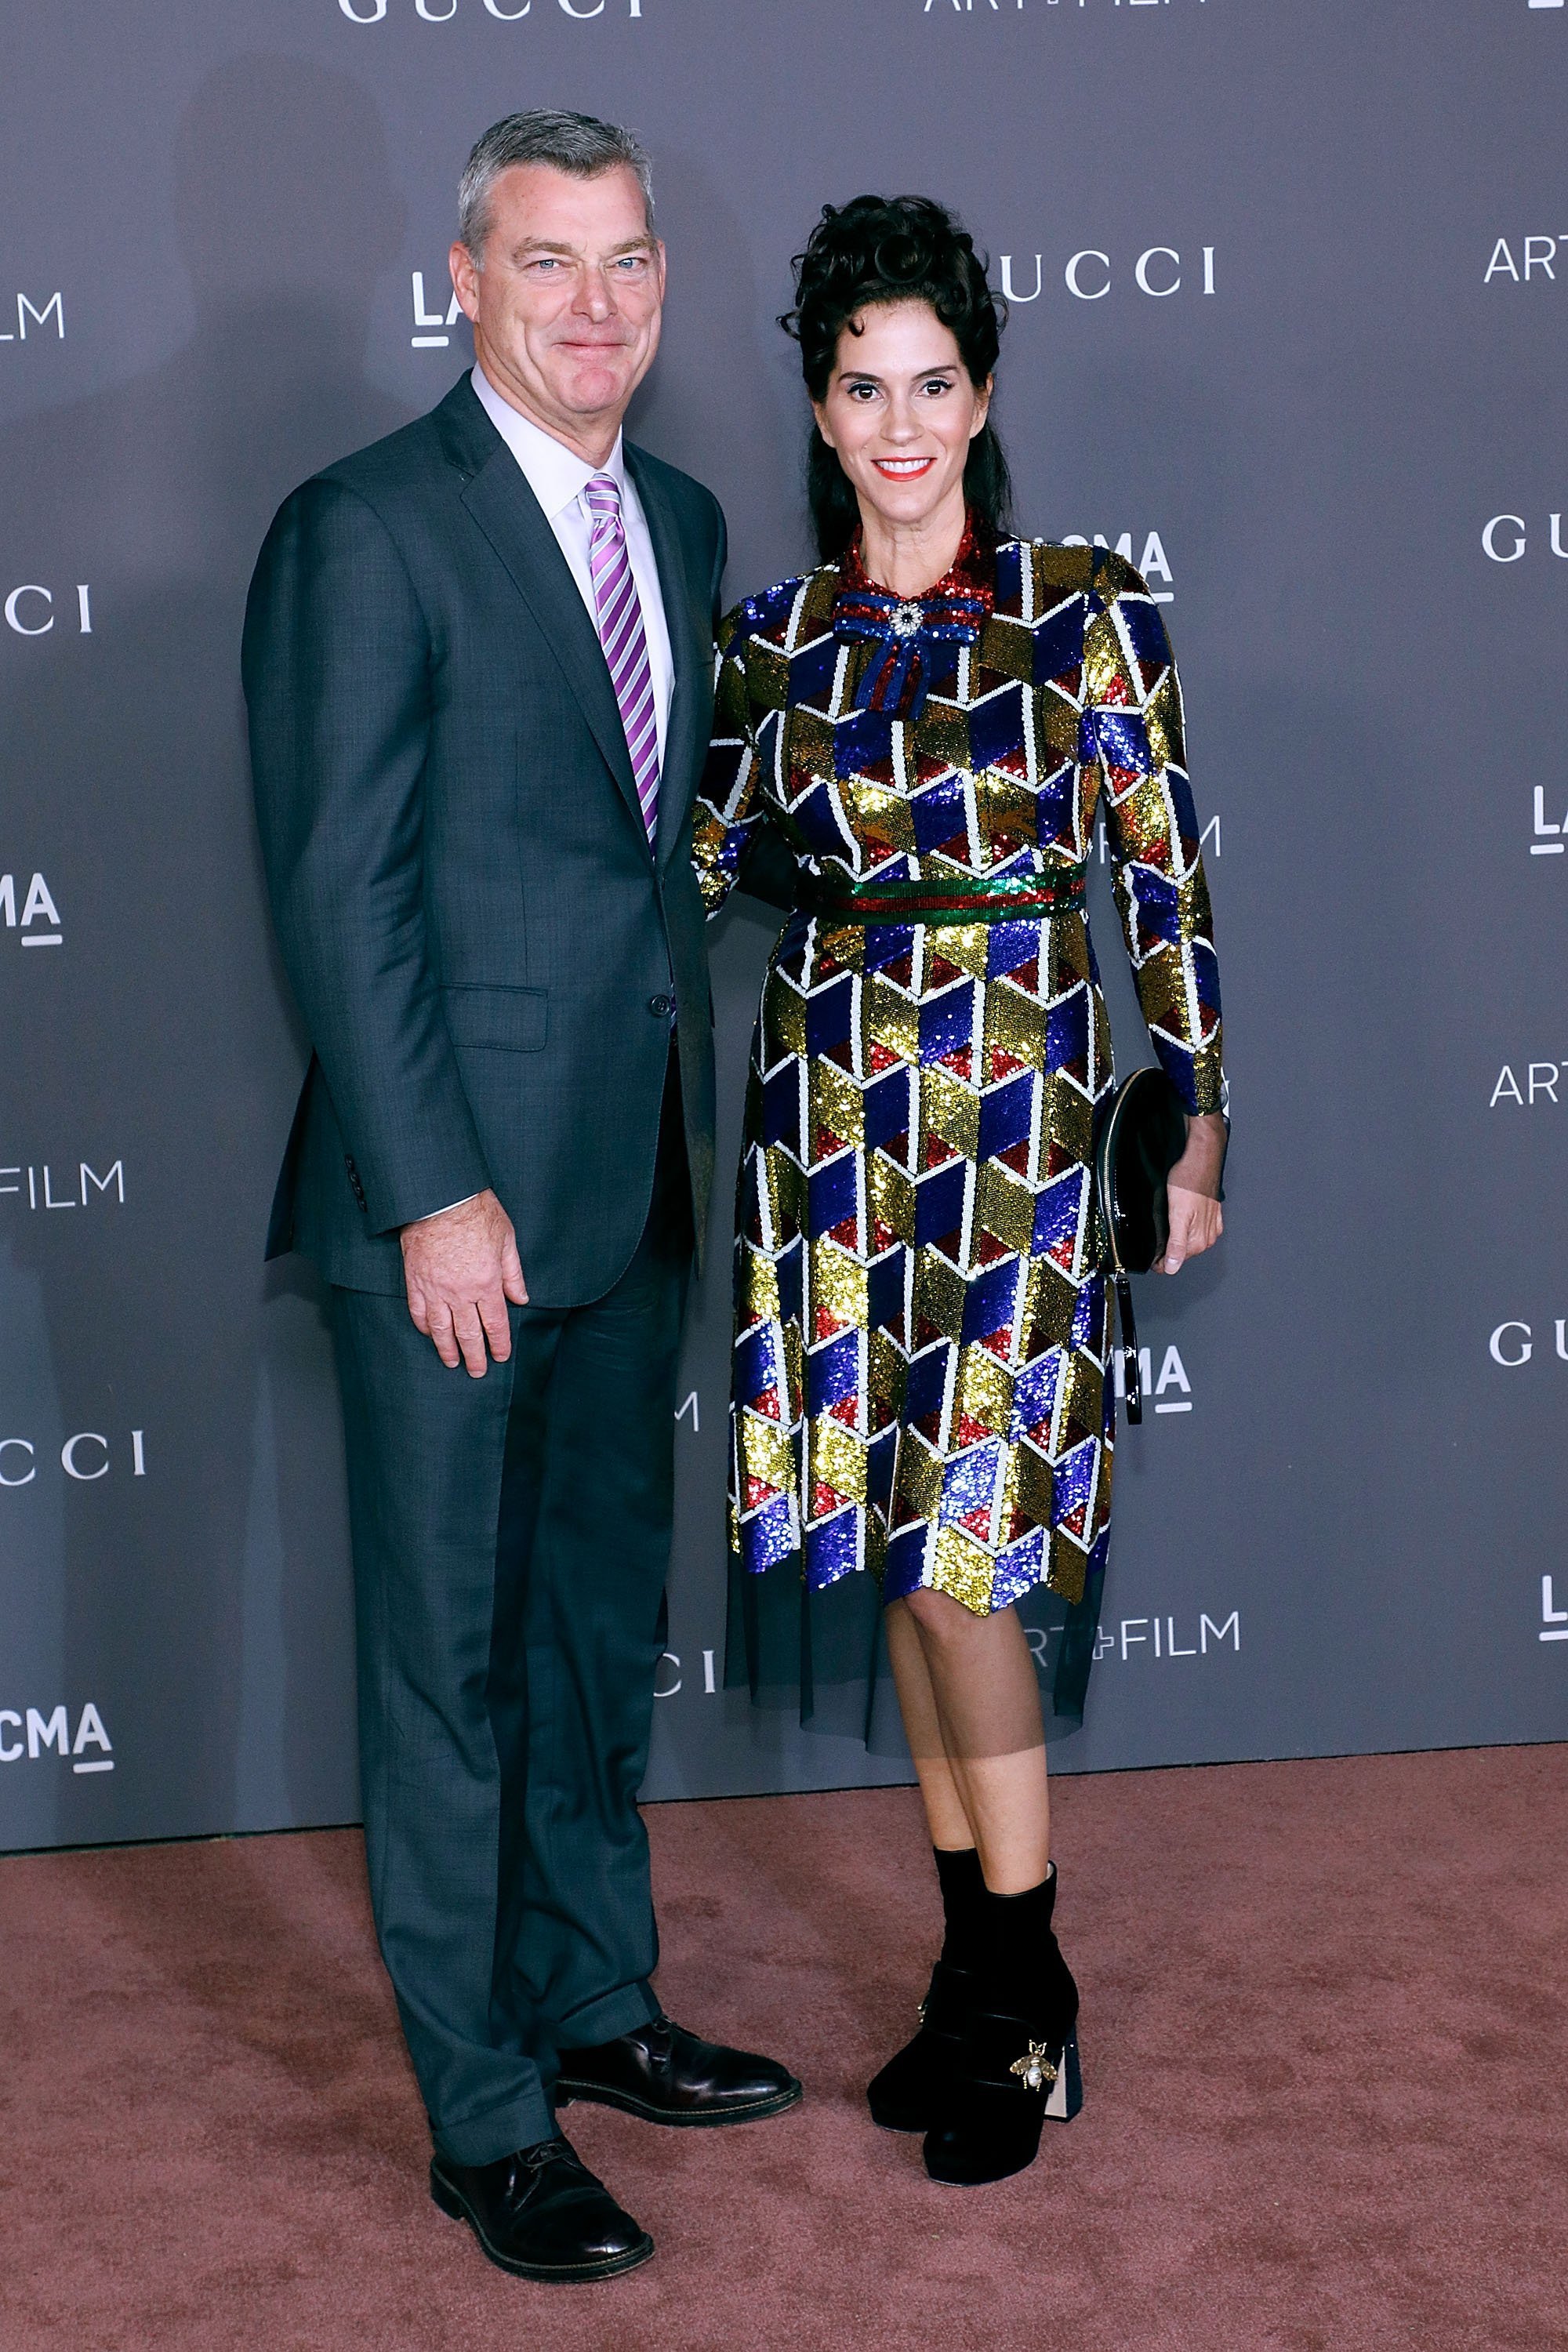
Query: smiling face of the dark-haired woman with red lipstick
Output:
[[811, 301, 992, 532]]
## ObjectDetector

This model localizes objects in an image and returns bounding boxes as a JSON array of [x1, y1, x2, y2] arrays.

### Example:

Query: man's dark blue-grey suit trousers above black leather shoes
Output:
[[332, 1070, 691, 2164]]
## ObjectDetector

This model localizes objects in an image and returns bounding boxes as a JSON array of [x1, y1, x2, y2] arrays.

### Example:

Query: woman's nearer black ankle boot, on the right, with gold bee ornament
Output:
[[926, 1865, 1083, 2187]]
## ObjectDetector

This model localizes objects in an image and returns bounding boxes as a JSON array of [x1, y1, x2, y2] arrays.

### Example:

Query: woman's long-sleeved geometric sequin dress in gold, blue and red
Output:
[[696, 527, 1225, 1719]]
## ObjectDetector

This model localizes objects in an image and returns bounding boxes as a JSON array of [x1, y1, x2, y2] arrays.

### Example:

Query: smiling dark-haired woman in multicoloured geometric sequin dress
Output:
[[696, 198, 1225, 2183]]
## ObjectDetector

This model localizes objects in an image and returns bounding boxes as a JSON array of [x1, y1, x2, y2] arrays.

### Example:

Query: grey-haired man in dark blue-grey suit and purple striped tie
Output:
[[245, 113, 799, 2279]]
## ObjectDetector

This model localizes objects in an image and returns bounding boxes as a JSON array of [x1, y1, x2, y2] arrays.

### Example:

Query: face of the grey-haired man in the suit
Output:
[[452, 162, 666, 466]]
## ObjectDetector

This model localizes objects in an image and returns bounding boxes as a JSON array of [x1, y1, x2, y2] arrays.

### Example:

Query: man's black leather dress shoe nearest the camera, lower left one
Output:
[[430, 2140, 654, 2281]]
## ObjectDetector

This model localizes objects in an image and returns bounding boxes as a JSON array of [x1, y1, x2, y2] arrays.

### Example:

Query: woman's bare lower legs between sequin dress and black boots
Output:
[[888, 1590, 1051, 1896]]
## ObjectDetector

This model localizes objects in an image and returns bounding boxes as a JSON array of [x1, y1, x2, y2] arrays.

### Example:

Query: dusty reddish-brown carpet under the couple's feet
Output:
[[0, 1748, 1568, 2352]]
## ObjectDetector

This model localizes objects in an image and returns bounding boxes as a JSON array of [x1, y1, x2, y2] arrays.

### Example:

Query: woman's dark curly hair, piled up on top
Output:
[[779, 195, 1013, 562]]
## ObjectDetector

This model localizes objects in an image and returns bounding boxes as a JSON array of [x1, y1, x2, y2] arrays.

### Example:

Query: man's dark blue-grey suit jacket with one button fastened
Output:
[[245, 376, 724, 1308]]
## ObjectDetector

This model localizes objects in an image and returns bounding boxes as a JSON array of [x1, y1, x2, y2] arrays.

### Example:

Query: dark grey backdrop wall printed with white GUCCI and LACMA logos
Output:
[[0, 0, 1568, 1846]]
